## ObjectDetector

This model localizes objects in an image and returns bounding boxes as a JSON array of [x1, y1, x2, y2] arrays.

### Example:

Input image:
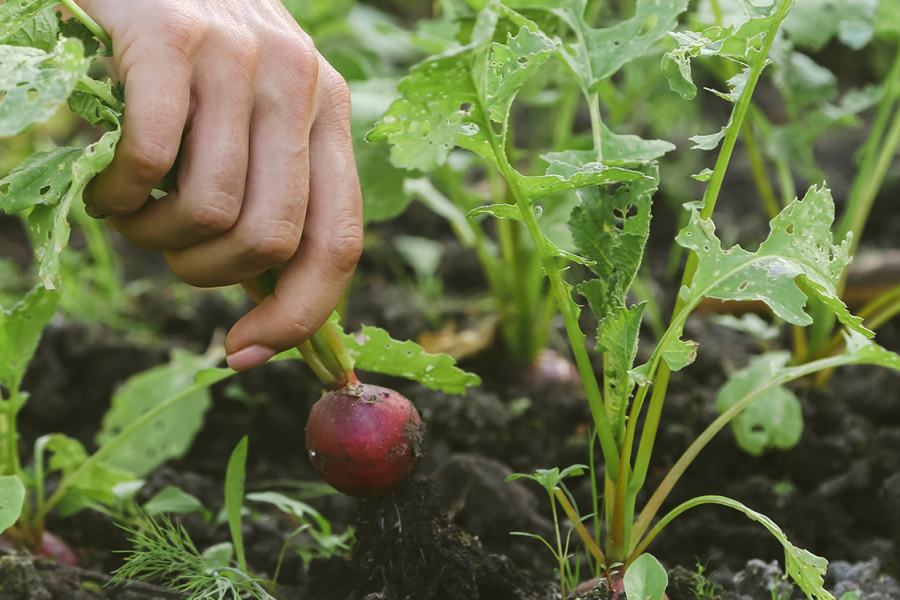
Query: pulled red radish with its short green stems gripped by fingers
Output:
[[243, 268, 425, 498]]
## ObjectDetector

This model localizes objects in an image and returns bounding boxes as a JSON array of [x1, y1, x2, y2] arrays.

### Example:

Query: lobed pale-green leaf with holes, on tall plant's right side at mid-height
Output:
[[676, 186, 873, 337]]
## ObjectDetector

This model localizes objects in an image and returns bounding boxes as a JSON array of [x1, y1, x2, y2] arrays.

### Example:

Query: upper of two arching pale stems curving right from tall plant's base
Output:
[[629, 355, 866, 556]]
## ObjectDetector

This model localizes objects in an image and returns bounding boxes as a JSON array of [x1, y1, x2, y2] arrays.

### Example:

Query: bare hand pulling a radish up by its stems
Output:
[[79, 0, 362, 371]]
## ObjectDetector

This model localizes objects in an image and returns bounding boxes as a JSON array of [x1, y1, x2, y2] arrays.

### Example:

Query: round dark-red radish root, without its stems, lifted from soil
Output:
[[306, 383, 425, 498]]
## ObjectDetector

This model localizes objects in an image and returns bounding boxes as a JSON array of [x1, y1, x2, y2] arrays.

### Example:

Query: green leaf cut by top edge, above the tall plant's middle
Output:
[[536, 0, 688, 91]]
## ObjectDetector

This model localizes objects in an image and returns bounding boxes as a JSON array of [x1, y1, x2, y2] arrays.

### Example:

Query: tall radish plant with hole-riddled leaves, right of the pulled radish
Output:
[[369, 0, 900, 599]]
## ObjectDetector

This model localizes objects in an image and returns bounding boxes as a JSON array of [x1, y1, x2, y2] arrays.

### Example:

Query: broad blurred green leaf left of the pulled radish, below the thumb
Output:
[[96, 349, 221, 476]]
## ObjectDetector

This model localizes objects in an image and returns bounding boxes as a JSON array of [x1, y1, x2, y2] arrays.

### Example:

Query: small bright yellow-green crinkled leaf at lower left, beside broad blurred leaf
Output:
[[41, 433, 135, 508]]
